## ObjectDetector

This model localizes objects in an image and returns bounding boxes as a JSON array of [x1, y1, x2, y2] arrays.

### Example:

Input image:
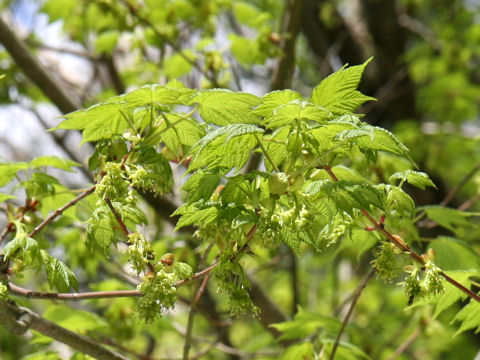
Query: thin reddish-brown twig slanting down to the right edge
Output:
[[323, 165, 480, 302]]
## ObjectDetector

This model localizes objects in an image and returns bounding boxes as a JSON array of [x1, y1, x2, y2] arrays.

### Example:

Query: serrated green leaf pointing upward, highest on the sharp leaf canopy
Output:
[[310, 58, 375, 115]]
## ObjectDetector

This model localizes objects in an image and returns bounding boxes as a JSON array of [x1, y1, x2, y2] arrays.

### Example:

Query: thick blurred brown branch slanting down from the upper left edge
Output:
[[0, 18, 81, 113]]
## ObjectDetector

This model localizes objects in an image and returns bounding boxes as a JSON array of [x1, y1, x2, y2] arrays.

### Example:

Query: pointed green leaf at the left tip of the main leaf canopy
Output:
[[51, 102, 129, 144]]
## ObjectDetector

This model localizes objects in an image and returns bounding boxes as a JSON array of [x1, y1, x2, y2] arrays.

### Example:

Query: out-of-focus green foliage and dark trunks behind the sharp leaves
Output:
[[0, 0, 480, 360]]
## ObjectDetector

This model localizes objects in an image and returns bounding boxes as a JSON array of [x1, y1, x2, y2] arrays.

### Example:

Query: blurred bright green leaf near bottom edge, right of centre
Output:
[[270, 307, 341, 340]]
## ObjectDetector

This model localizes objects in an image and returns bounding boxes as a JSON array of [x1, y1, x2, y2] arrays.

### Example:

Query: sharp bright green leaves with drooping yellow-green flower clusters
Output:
[[1, 54, 480, 356]]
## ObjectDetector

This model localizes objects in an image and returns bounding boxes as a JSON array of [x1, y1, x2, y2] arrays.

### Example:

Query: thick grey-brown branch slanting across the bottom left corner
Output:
[[0, 301, 127, 360]]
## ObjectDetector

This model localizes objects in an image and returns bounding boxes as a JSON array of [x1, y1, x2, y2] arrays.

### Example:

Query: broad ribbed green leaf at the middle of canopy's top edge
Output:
[[191, 89, 261, 126]]
